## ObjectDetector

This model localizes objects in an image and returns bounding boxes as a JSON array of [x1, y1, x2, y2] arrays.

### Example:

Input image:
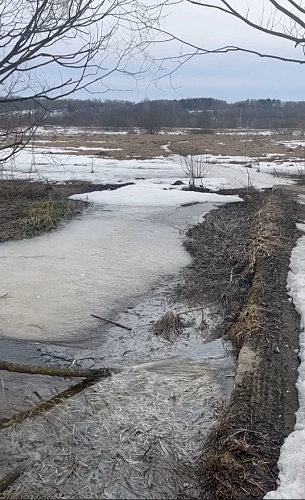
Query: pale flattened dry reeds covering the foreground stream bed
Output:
[[0, 363, 217, 499]]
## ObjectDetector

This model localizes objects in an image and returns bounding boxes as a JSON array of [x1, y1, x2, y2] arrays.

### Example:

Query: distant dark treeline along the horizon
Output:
[[0, 97, 305, 134]]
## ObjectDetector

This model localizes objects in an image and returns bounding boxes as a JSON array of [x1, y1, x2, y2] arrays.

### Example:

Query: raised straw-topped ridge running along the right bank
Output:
[[195, 193, 295, 500]]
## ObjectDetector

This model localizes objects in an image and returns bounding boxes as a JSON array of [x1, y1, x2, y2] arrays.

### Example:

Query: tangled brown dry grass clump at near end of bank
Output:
[[202, 408, 270, 500]]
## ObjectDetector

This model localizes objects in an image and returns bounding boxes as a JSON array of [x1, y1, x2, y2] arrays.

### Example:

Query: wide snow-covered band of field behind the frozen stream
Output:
[[0, 147, 296, 196]]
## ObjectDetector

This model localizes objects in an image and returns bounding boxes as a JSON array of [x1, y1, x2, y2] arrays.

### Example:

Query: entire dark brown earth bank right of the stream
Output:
[[180, 190, 299, 499]]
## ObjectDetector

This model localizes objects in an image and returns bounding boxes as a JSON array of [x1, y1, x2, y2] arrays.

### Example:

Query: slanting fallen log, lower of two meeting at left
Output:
[[0, 377, 96, 429]]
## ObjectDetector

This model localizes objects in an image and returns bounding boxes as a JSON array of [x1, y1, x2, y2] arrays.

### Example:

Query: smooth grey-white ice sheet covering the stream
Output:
[[0, 205, 198, 341]]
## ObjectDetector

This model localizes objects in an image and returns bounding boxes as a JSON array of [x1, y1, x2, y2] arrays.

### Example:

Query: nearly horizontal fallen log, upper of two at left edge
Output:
[[0, 361, 110, 379]]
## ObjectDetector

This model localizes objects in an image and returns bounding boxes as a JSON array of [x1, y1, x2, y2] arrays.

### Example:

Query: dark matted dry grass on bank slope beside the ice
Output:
[[177, 190, 263, 338]]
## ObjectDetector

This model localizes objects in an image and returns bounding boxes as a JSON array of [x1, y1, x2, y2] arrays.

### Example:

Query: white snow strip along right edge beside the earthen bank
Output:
[[264, 224, 305, 500]]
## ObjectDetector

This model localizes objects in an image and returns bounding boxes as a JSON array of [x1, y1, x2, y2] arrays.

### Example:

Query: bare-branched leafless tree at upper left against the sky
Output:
[[0, 0, 162, 163]]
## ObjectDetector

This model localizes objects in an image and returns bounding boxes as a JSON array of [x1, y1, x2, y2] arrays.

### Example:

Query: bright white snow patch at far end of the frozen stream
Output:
[[71, 182, 242, 207]]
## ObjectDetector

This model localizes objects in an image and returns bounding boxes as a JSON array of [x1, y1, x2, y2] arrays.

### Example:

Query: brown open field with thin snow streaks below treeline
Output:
[[28, 128, 305, 160]]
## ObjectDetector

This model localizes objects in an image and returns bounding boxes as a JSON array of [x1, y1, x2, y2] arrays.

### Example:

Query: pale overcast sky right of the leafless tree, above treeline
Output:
[[79, 0, 305, 102]]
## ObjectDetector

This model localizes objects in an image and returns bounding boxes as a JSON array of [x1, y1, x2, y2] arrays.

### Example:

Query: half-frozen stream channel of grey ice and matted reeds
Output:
[[0, 203, 234, 498]]
